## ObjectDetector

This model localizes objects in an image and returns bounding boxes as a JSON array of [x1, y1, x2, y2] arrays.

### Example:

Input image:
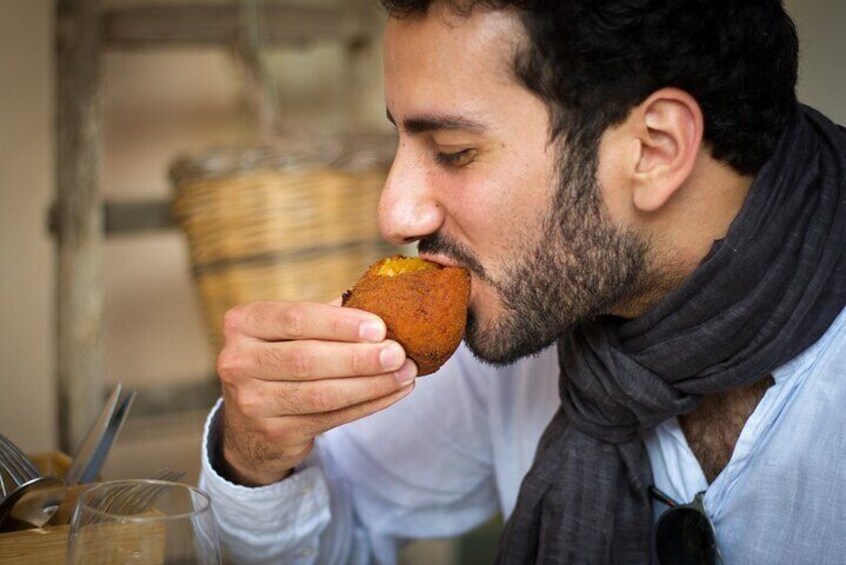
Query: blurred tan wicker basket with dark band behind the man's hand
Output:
[[171, 136, 400, 350]]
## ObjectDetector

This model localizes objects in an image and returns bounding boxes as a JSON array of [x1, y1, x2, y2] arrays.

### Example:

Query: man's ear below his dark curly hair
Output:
[[627, 88, 705, 212]]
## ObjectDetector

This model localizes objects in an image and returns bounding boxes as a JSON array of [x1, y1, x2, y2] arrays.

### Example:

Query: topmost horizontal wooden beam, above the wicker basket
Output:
[[100, 3, 378, 48]]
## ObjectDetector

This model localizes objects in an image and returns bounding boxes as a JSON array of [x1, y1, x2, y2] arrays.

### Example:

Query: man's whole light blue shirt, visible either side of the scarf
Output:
[[201, 311, 846, 565]]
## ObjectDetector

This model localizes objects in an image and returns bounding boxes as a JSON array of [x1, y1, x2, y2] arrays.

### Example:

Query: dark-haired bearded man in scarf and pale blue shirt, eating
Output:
[[202, 0, 846, 564]]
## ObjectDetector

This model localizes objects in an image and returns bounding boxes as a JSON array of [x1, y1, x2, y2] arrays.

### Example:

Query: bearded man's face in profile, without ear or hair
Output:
[[380, 4, 647, 363]]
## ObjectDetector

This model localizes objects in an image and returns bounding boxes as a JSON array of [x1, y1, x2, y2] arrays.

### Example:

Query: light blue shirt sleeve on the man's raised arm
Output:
[[200, 344, 499, 564]]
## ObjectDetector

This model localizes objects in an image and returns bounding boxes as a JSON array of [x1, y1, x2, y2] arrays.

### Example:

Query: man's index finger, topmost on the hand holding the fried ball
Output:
[[223, 301, 387, 342]]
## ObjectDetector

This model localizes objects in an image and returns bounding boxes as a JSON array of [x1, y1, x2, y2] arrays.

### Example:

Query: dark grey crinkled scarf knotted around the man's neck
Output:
[[497, 106, 846, 565]]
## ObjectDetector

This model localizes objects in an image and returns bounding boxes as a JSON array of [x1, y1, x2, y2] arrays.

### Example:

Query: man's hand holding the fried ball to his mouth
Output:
[[217, 302, 417, 486]]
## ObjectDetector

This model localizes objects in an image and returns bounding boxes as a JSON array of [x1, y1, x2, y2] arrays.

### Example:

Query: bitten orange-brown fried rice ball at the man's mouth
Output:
[[342, 255, 470, 376]]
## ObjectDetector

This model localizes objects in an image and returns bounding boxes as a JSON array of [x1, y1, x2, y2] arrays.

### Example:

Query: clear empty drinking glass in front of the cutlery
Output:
[[66, 479, 221, 565]]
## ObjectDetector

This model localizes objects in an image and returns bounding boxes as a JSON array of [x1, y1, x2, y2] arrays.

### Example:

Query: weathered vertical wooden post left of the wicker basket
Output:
[[56, 0, 105, 453]]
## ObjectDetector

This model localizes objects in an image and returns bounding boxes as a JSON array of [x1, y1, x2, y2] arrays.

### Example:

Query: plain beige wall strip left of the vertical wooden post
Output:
[[0, 0, 56, 450]]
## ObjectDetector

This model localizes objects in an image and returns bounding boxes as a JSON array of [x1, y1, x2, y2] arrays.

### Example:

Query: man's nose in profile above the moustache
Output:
[[379, 147, 444, 245]]
